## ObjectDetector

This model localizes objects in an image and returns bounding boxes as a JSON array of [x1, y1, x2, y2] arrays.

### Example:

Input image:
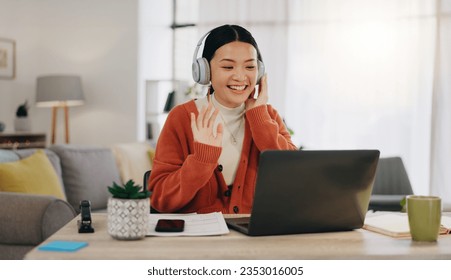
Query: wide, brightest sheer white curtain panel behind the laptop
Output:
[[286, 0, 436, 198]]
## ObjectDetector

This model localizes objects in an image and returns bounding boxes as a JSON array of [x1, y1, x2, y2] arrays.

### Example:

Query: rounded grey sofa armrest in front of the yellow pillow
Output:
[[0, 192, 75, 259]]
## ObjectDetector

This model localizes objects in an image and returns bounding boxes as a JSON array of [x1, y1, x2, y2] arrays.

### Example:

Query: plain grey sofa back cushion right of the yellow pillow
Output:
[[50, 145, 120, 213]]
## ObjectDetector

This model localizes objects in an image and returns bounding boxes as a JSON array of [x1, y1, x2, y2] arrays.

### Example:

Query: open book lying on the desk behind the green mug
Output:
[[362, 212, 451, 238]]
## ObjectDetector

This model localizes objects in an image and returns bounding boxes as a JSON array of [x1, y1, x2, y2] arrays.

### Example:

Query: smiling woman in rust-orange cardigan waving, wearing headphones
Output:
[[149, 25, 297, 213]]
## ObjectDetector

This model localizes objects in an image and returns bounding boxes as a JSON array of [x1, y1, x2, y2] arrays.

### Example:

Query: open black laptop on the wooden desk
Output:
[[226, 150, 380, 236]]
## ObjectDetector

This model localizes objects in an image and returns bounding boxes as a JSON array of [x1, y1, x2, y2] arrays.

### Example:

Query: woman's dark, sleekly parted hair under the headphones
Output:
[[202, 24, 263, 93]]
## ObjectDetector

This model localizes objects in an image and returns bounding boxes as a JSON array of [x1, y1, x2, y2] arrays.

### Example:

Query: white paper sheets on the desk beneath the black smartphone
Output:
[[147, 212, 230, 236]]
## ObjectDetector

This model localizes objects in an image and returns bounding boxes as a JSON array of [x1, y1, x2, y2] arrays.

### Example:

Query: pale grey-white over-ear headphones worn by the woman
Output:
[[192, 31, 265, 85]]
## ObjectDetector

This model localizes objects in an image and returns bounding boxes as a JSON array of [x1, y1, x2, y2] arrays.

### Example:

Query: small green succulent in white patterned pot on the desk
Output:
[[108, 180, 150, 240]]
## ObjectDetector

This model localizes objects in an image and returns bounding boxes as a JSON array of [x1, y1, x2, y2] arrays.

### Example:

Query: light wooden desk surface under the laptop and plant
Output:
[[25, 214, 451, 260]]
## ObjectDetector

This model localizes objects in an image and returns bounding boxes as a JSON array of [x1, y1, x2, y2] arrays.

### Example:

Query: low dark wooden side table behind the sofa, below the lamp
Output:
[[0, 132, 46, 149]]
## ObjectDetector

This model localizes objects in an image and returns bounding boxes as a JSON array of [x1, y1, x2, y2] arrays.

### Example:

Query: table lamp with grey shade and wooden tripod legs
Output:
[[36, 75, 84, 144]]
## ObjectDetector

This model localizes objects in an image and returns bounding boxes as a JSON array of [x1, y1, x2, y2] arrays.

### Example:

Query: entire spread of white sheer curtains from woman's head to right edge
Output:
[[199, 0, 451, 208]]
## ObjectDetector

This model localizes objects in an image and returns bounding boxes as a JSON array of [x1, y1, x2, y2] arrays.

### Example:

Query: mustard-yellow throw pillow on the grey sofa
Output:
[[0, 150, 65, 199]]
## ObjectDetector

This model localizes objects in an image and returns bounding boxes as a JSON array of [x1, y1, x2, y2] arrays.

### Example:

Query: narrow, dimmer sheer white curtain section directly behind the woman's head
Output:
[[198, 0, 289, 111]]
